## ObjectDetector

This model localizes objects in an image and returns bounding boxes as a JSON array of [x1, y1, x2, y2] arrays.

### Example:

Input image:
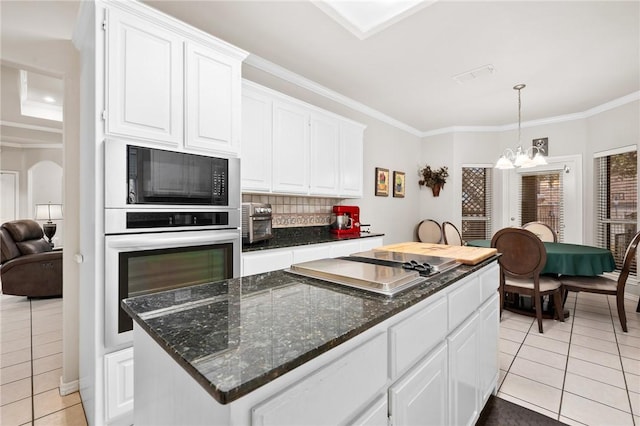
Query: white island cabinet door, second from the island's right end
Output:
[[447, 312, 480, 425]]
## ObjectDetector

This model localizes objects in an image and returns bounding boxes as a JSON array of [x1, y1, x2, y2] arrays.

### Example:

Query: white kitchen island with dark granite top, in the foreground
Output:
[[123, 253, 499, 425]]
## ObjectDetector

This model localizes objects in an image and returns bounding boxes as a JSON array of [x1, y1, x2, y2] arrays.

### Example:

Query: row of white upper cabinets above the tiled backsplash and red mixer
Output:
[[241, 80, 365, 198]]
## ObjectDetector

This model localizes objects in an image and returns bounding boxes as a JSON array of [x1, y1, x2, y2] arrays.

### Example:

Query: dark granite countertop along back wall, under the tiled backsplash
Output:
[[242, 226, 384, 253]]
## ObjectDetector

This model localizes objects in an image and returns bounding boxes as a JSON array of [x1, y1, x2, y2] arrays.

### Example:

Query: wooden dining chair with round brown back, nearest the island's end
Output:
[[491, 228, 564, 333]]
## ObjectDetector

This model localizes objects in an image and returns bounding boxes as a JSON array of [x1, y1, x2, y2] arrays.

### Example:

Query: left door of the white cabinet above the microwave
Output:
[[106, 9, 184, 145]]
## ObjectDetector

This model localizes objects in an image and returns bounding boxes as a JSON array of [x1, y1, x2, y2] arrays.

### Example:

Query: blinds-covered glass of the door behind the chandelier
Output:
[[520, 171, 564, 241]]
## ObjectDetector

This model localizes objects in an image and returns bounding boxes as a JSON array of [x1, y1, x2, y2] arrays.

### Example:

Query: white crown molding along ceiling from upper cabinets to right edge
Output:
[[244, 53, 640, 138]]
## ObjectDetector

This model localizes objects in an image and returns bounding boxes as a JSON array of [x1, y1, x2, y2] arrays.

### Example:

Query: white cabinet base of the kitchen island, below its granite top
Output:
[[131, 263, 499, 426]]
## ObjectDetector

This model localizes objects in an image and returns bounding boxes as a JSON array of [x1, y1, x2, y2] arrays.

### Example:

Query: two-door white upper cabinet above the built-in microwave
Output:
[[105, 2, 246, 156]]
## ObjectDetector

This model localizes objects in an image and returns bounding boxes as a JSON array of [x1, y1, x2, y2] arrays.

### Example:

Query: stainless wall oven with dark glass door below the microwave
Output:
[[105, 229, 241, 348]]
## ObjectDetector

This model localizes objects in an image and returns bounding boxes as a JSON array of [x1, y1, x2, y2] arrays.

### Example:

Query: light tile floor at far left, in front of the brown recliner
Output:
[[0, 295, 87, 426]]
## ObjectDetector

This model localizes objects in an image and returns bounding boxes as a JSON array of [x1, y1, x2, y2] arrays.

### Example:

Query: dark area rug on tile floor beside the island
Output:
[[476, 395, 564, 426]]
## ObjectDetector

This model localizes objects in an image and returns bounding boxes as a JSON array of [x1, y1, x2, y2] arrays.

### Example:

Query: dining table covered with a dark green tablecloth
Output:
[[467, 240, 616, 277]]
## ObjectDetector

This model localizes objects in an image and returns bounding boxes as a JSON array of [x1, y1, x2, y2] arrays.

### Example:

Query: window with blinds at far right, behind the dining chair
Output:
[[594, 148, 638, 276]]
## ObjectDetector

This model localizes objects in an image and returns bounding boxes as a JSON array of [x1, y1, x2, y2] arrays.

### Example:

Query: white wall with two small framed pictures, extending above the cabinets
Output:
[[242, 64, 424, 244]]
